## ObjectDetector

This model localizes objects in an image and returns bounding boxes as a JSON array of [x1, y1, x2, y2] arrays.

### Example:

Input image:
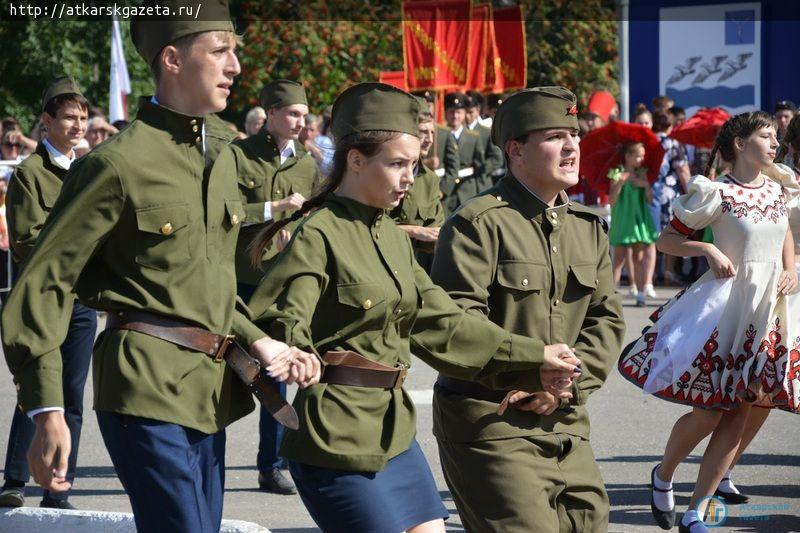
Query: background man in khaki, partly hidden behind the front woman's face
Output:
[[389, 97, 444, 272]]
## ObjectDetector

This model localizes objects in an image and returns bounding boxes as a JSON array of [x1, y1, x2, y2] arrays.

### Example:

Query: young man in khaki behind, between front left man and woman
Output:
[[231, 80, 319, 494]]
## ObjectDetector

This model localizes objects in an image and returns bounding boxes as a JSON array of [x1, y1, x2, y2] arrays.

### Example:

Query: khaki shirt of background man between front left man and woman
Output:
[[231, 129, 319, 285]]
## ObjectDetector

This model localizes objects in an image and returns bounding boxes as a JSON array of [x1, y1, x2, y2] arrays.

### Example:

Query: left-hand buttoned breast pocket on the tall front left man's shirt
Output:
[[136, 203, 191, 270]]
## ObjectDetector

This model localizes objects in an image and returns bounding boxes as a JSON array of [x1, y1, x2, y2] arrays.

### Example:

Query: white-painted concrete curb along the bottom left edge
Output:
[[0, 507, 270, 533]]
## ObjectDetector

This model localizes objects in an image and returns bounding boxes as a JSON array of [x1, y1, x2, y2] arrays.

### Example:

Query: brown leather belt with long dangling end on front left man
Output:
[[106, 310, 300, 429]]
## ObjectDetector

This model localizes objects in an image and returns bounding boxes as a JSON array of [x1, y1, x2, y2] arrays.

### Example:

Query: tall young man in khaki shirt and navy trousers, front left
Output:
[[2, 1, 318, 533]]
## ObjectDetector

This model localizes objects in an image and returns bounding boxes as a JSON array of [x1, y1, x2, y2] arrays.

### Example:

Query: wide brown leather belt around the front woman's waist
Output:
[[320, 351, 408, 389]]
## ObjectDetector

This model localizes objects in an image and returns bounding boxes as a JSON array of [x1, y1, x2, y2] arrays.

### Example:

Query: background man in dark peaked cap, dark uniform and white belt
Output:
[[442, 93, 491, 215]]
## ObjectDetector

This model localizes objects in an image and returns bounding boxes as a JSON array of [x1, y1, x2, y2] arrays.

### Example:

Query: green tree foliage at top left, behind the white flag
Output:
[[0, 20, 153, 130]]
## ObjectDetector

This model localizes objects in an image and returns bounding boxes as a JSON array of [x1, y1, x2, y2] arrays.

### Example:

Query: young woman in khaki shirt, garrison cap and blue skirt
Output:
[[245, 83, 579, 533]]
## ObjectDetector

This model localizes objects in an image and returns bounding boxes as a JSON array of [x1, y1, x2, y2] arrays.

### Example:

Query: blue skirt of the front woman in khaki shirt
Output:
[[289, 439, 449, 533]]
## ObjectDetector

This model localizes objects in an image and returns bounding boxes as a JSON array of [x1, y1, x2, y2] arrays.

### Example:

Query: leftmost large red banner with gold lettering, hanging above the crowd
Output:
[[403, 0, 472, 91]]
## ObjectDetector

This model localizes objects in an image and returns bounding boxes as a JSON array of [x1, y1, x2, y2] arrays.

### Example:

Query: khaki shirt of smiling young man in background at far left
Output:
[[6, 142, 67, 265]]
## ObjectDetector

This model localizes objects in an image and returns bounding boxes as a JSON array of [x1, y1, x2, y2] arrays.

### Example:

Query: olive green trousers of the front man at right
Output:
[[438, 433, 609, 533]]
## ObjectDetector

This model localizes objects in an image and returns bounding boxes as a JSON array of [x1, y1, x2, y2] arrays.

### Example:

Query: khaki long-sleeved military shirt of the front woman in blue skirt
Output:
[[250, 196, 543, 472]]
